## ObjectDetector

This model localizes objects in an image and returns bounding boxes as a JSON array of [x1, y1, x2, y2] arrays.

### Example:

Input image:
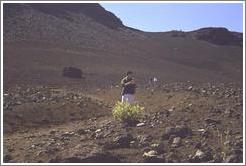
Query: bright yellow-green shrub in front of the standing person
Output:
[[113, 101, 144, 122]]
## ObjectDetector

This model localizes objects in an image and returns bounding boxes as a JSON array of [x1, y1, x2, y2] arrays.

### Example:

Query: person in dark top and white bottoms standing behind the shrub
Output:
[[121, 71, 136, 103]]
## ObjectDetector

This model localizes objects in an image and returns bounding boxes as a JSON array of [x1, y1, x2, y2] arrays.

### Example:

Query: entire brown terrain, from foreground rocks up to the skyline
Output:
[[3, 4, 243, 163]]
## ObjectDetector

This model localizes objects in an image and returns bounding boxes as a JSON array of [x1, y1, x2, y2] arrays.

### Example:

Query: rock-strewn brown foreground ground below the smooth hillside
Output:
[[4, 82, 243, 163]]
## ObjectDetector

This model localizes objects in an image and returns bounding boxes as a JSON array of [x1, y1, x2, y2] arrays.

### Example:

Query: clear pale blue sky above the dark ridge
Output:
[[100, 3, 243, 32]]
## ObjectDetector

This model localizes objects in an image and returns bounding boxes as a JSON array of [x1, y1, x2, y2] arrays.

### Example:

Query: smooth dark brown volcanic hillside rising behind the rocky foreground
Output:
[[3, 3, 243, 86]]
